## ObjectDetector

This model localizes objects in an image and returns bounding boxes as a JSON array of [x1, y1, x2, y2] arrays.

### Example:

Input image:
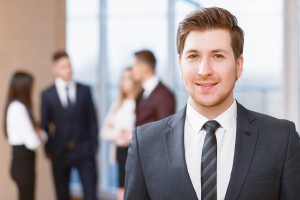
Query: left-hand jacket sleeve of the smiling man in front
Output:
[[124, 129, 150, 200]]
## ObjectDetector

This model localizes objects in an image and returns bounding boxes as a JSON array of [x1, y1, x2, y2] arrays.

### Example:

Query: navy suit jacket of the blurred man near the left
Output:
[[41, 83, 98, 158]]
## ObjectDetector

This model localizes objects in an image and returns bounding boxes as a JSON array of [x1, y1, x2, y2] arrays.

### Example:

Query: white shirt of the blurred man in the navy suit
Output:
[[55, 78, 76, 108]]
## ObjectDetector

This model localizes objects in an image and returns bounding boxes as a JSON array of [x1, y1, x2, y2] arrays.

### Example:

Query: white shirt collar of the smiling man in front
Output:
[[186, 97, 237, 133]]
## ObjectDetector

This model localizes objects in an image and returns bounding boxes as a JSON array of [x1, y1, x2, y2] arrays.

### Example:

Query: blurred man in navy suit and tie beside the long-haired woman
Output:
[[41, 51, 98, 200]]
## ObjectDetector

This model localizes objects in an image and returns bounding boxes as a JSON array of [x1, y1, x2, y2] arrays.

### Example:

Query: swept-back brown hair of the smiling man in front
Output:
[[177, 7, 244, 59]]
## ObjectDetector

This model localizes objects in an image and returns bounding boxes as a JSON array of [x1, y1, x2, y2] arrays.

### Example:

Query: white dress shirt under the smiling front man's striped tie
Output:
[[184, 100, 237, 200]]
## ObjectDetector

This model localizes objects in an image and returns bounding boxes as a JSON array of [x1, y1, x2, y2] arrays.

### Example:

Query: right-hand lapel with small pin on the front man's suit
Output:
[[225, 104, 258, 200]]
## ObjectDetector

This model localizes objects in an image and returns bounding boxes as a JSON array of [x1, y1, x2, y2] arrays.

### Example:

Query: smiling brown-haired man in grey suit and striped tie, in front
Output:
[[125, 7, 300, 200]]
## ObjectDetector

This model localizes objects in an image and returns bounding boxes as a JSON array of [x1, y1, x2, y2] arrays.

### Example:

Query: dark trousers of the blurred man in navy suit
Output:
[[52, 151, 97, 200]]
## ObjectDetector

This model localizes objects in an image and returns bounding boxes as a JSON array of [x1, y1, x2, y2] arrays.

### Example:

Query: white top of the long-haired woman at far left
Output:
[[6, 101, 40, 150]]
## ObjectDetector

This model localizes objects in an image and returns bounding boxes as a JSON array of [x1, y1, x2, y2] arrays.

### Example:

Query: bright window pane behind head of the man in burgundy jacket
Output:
[[107, 0, 168, 97]]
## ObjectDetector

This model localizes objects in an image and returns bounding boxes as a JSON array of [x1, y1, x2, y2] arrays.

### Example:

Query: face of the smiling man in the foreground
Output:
[[179, 29, 243, 115]]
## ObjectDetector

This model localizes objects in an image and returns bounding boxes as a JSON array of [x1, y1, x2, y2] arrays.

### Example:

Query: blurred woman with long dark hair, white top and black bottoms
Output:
[[4, 72, 46, 200]]
